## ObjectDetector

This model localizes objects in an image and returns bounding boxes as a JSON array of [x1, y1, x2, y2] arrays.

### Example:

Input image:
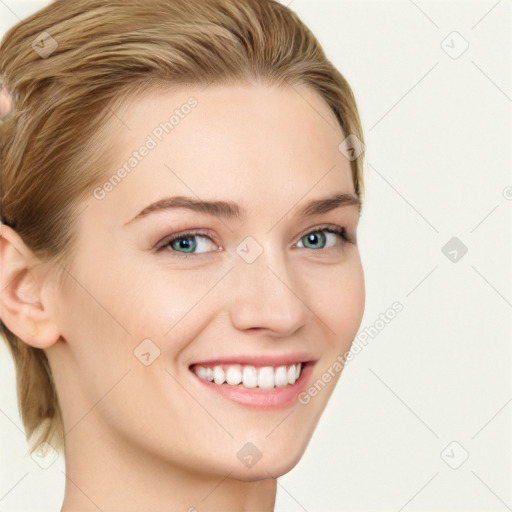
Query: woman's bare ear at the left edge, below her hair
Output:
[[0, 223, 60, 349]]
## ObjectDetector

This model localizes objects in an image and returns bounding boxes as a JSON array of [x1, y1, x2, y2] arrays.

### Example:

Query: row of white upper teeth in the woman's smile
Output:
[[193, 363, 302, 389]]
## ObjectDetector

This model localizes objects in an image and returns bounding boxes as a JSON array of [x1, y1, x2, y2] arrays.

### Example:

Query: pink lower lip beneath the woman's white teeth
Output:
[[190, 363, 314, 410]]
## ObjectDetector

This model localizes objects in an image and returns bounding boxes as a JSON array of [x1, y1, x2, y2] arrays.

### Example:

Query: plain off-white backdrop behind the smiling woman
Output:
[[0, 0, 512, 512]]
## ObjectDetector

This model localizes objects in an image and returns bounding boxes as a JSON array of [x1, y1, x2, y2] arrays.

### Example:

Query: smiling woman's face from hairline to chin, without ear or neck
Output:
[[48, 85, 364, 480]]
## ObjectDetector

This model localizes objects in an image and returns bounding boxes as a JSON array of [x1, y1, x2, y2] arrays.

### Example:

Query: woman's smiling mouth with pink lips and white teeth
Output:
[[189, 360, 316, 410]]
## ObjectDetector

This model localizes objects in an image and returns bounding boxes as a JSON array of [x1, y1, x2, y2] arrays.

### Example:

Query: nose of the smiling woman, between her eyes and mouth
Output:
[[230, 249, 312, 337]]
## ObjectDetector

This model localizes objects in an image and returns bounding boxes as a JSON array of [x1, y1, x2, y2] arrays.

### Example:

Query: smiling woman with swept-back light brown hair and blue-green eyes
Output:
[[0, 0, 365, 512]]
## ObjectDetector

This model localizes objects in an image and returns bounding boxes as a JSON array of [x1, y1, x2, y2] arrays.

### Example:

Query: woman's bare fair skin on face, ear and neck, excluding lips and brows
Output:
[[0, 85, 365, 512]]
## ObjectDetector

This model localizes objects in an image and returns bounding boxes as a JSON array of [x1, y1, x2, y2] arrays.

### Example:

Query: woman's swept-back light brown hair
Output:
[[0, 0, 363, 452]]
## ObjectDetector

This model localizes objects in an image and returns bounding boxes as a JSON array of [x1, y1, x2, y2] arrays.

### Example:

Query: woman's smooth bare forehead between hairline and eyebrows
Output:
[[87, 85, 354, 222]]
